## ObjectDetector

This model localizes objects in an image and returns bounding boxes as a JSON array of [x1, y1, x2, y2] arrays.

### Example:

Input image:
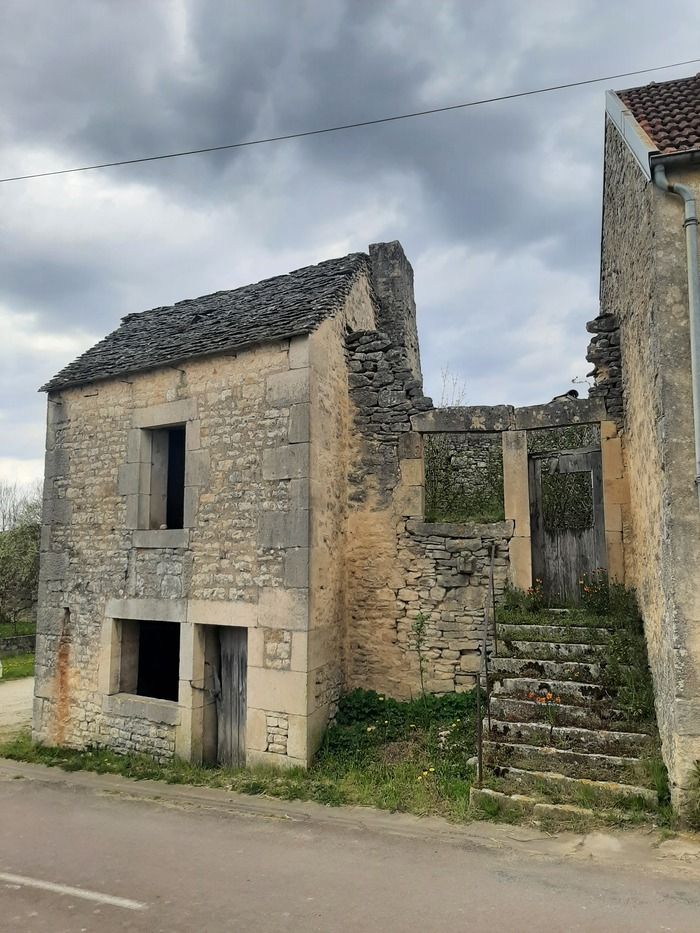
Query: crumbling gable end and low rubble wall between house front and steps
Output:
[[344, 331, 513, 698]]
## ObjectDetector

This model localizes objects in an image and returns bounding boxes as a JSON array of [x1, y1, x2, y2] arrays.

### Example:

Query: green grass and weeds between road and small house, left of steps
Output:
[[0, 691, 482, 821]]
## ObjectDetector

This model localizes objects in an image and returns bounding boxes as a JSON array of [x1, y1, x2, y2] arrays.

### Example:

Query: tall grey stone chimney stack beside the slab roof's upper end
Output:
[[369, 240, 423, 382]]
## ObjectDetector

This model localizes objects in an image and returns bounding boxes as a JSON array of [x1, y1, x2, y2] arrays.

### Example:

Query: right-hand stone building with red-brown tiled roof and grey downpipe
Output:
[[589, 76, 700, 793]]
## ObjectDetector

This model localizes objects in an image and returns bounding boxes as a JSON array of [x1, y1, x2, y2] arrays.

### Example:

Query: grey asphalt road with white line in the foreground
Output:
[[0, 772, 700, 933]]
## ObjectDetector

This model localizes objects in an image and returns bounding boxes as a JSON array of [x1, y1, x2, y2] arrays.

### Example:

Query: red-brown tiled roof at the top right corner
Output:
[[617, 75, 700, 153]]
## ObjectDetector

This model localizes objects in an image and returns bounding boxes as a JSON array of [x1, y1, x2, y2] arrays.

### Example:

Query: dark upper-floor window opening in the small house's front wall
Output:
[[150, 424, 185, 528]]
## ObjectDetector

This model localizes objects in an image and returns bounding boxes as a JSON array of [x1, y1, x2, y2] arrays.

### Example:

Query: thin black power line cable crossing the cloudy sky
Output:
[[0, 58, 700, 184]]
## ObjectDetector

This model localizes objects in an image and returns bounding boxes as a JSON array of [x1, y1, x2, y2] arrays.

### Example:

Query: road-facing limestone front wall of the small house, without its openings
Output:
[[34, 338, 309, 762]]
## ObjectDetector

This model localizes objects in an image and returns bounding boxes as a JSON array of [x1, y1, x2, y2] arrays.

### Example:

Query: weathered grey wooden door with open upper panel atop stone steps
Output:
[[529, 448, 607, 603]]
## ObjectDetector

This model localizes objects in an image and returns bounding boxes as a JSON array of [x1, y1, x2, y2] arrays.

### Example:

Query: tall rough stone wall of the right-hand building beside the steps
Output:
[[597, 124, 700, 799]]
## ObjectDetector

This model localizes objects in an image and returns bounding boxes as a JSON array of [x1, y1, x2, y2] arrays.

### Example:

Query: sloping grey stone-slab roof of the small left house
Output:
[[41, 253, 369, 392]]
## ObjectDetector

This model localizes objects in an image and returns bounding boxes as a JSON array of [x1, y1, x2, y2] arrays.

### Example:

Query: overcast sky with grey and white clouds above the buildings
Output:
[[0, 0, 700, 488]]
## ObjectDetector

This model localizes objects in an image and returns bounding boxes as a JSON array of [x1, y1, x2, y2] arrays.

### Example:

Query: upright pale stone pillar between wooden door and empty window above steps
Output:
[[503, 431, 532, 590]]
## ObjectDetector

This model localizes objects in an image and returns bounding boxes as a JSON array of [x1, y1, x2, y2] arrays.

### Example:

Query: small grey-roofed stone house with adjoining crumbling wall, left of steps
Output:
[[34, 243, 510, 764]]
